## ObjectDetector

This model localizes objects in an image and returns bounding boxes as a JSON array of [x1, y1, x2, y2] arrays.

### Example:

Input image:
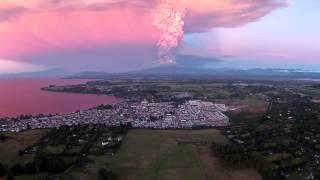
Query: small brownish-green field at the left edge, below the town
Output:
[[0, 129, 49, 167]]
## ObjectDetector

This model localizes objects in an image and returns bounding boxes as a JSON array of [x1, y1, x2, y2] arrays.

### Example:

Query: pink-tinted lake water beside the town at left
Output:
[[0, 78, 118, 117]]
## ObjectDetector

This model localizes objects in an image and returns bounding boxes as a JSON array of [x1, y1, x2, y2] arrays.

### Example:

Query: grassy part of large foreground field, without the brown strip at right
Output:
[[84, 130, 227, 180]]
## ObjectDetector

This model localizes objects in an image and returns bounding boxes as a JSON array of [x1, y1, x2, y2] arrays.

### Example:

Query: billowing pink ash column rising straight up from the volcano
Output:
[[152, 0, 187, 64]]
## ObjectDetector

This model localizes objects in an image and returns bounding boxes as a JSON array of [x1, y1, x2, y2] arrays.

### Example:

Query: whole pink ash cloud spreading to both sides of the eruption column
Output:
[[0, 0, 288, 67]]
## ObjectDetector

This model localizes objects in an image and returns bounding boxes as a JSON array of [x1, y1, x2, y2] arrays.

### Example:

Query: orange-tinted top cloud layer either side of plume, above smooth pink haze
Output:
[[0, 0, 290, 32]]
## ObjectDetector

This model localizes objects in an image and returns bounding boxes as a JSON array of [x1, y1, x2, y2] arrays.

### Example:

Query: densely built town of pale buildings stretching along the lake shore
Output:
[[0, 100, 229, 132]]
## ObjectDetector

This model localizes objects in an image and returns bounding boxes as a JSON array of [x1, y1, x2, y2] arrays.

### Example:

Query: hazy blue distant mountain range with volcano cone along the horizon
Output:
[[70, 65, 320, 79]]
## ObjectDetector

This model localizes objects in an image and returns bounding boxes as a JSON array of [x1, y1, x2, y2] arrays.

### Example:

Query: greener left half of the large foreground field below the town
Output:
[[105, 130, 160, 180]]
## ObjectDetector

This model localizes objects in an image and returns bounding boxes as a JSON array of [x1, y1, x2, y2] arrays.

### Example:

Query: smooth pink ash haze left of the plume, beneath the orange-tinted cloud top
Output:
[[0, 8, 158, 59]]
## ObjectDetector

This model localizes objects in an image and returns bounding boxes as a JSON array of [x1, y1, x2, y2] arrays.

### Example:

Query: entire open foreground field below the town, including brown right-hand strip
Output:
[[72, 129, 261, 180]]
